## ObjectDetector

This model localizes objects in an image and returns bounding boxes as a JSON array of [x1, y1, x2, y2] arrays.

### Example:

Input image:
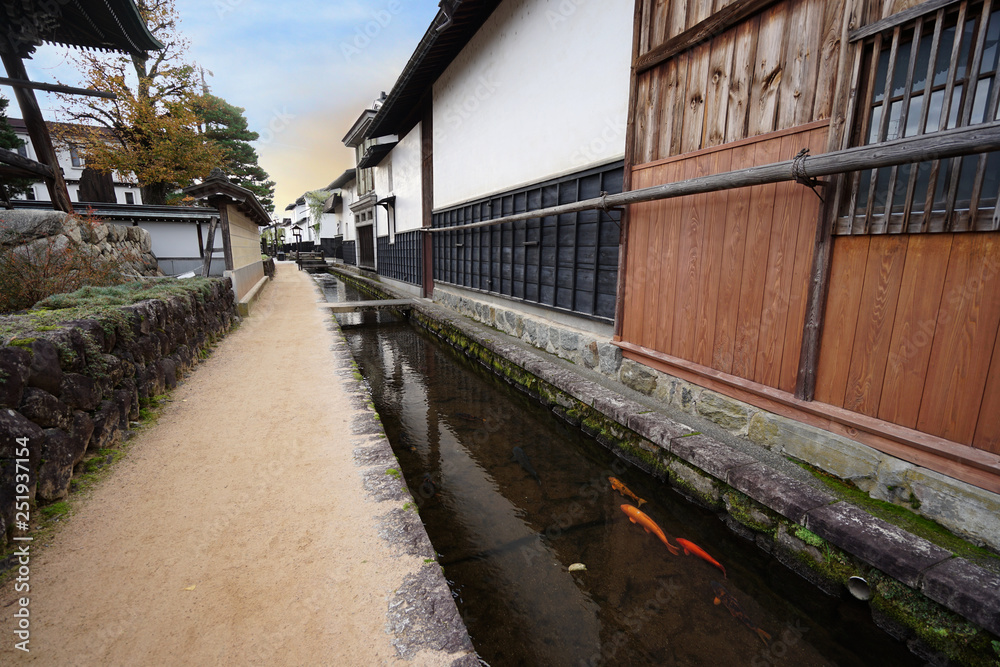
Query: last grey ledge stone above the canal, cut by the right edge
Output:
[[920, 558, 1000, 636]]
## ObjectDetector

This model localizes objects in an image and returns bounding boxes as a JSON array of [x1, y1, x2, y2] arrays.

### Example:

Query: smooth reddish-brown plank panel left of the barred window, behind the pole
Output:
[[622, 123, 827, 392]]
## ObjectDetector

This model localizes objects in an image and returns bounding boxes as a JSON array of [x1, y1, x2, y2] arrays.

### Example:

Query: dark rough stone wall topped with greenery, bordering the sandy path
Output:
[[0, 279, 236, 545]]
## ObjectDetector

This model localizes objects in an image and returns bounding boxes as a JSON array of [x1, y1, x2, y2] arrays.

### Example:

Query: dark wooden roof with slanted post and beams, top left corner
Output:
[[0, 0, 163, 213]]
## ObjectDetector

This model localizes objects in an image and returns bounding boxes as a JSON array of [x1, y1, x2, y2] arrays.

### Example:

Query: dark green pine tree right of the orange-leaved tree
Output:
[[194, 91, 275, 213]]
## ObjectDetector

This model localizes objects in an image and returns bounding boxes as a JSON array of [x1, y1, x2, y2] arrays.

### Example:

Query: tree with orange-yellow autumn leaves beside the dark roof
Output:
[[56, 0, 224, 204]]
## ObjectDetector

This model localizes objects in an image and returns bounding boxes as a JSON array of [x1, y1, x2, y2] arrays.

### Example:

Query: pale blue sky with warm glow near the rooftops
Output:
[[17, 0, 438, 216]]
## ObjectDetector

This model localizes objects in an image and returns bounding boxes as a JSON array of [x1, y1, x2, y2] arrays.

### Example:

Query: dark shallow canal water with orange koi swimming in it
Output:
[[324, 279, 921, 667]]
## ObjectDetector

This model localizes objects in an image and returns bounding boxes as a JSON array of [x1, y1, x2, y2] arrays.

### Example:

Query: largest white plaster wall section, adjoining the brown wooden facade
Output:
[[433, 0, 634, 209]]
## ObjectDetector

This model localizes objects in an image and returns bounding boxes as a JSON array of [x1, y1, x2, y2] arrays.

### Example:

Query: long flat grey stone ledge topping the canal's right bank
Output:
[[332, 266, 1000, 648]]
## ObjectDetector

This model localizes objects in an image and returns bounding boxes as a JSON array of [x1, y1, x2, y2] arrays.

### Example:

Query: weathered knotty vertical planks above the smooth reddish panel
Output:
[[633, 0, 844, 164]]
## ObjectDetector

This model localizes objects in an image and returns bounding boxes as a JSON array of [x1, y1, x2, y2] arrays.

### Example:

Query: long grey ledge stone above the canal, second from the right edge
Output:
[[806, 502, 951, 588]]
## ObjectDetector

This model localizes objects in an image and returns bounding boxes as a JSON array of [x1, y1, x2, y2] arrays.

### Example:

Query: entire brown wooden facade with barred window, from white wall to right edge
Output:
[[616, 0, 1000, 492]]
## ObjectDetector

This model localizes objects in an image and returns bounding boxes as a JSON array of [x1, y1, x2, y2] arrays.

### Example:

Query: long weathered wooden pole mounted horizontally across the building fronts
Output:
[[421, 121, 1000, 234]]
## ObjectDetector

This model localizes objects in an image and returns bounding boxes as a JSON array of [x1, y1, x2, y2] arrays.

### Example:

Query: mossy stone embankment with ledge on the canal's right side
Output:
[[337, 272, 1000, 665]]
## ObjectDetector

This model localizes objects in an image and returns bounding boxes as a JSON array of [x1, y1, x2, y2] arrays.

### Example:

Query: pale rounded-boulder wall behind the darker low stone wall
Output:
[[0, 210, 163, 276]]
